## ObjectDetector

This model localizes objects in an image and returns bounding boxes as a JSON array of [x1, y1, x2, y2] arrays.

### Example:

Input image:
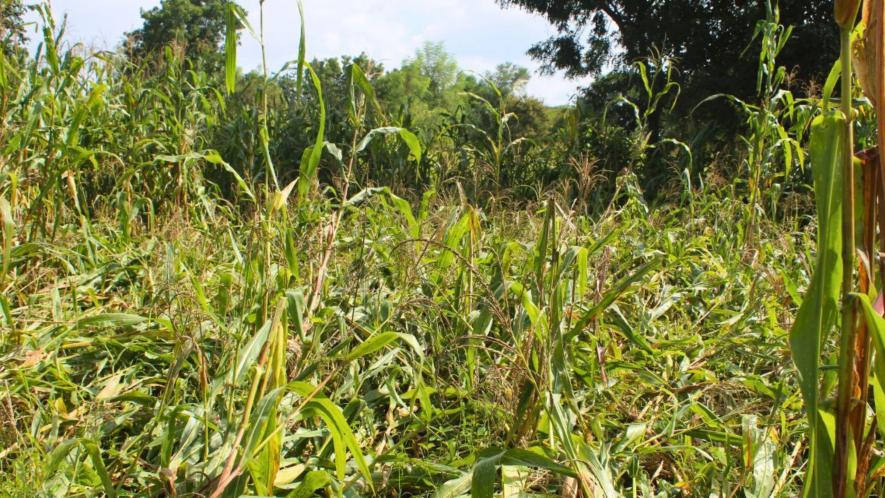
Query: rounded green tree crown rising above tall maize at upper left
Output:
[[126, 0, 238, 71]]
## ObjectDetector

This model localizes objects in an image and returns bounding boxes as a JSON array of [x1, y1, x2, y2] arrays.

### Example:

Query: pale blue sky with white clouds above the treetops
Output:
[[25, 0, 587, 105]]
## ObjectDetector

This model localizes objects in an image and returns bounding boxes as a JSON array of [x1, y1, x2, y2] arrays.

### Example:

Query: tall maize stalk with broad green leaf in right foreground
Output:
[[790, 0, 885, 498]]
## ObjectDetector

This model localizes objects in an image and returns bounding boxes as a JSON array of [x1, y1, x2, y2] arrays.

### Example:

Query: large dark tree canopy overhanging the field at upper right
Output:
[[498, 0, 839, 105]]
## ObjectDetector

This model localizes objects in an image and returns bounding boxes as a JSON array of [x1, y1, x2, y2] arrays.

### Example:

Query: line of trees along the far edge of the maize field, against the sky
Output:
[[0, 0, 838, 209]]
